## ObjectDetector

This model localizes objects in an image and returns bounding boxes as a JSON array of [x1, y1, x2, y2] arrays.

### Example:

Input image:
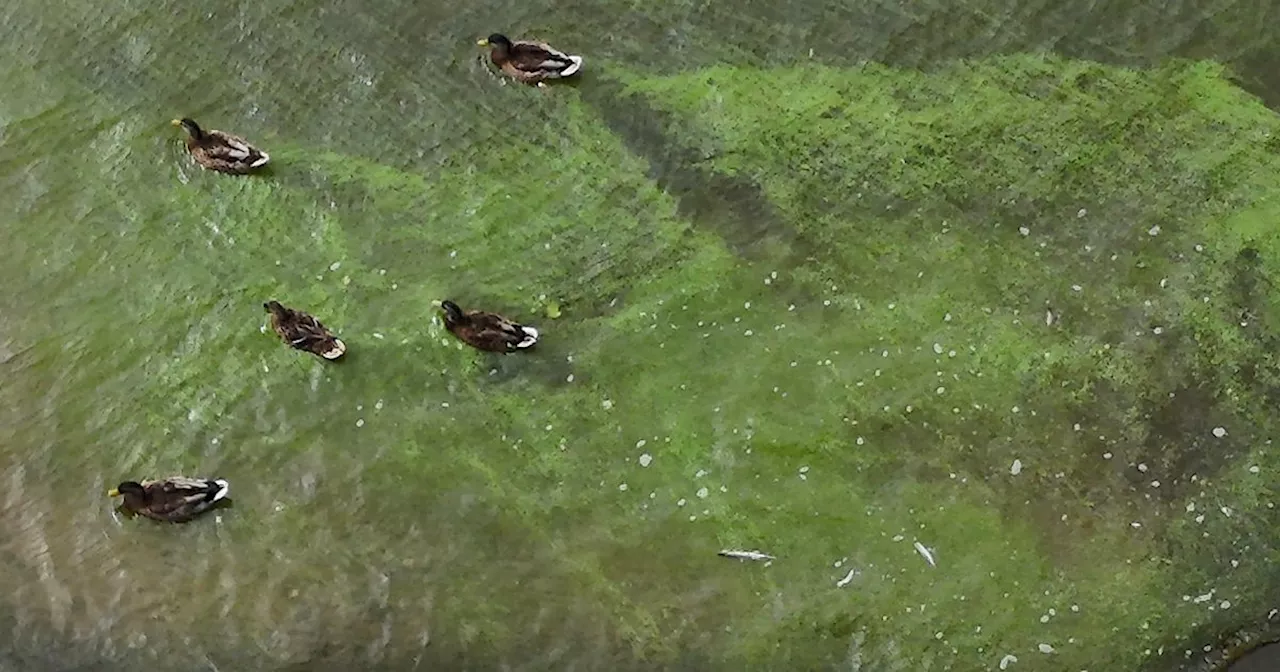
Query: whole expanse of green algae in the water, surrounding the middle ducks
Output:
[[2, 34, 1280, 669]]
